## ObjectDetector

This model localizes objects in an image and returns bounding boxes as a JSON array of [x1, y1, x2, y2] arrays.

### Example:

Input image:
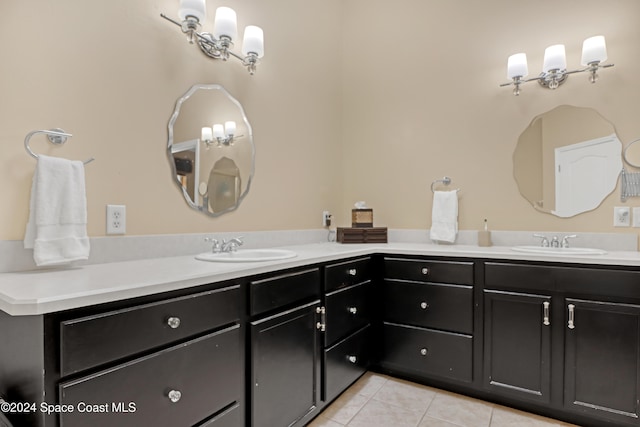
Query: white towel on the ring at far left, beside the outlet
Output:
[[24, 155, 89, 266]]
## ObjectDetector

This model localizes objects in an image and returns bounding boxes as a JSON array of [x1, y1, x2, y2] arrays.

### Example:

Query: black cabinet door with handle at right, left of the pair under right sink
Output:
[[484, 290, 551, 403]]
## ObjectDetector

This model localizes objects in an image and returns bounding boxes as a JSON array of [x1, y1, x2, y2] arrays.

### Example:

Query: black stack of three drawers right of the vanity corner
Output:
[[379, 258, 474, 383]]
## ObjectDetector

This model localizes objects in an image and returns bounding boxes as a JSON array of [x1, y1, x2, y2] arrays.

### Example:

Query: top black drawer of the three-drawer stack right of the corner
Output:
[[384, 258, 473, 285]]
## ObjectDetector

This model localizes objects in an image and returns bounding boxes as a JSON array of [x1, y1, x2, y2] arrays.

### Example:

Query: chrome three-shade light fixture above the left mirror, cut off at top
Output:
[[160, 0, 264, 75]]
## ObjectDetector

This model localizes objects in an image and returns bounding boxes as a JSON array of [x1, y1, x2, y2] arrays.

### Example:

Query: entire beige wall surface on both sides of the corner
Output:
[[0, 0, 640, 239]]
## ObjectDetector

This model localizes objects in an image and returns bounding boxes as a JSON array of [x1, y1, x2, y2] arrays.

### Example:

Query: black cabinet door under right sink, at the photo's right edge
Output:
[[564, 299, 640, 425]]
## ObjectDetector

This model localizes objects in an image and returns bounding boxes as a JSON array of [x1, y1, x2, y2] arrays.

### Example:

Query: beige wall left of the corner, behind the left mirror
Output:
[[0, 0, 342, 239]]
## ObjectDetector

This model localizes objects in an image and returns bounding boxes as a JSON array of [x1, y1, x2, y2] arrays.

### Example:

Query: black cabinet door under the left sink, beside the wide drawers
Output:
[[251, 301, 320, 427]]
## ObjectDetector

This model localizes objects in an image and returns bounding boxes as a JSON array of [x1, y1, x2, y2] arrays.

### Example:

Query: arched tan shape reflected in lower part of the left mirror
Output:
[[207, 157, 241, 212]]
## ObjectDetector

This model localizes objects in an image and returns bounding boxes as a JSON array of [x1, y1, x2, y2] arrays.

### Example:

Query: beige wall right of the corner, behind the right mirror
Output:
[[343, 0, 640, 237]]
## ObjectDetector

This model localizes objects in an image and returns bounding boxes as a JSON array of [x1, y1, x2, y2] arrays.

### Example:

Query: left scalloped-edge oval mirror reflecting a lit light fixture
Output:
[[167, 84, 255, 216]]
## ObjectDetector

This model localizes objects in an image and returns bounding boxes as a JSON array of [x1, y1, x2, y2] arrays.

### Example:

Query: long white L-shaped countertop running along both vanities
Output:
[[0, 243, 640, 316]]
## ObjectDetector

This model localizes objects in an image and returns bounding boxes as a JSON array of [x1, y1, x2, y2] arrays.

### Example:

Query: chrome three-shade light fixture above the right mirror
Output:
[[500, 36, 613, 96]]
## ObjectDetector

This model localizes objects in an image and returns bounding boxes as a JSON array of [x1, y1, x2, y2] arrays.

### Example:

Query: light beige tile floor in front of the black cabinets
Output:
[[309, 372, 573, 427]]
